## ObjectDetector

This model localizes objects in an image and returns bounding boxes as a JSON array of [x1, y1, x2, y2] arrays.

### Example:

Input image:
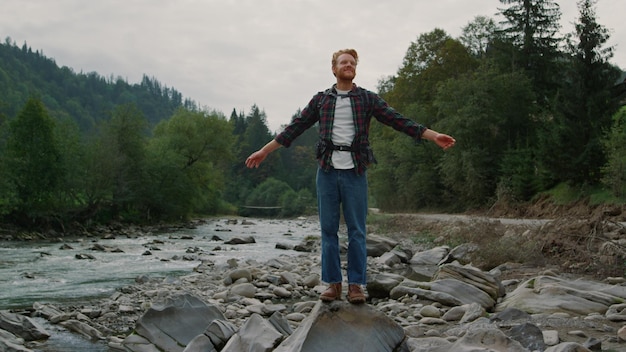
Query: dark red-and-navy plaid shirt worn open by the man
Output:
[[275, 84, 426, 174]]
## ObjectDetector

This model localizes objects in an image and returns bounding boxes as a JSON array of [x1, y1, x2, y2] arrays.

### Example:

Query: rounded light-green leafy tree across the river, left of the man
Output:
[[145, 109, 234, 219]]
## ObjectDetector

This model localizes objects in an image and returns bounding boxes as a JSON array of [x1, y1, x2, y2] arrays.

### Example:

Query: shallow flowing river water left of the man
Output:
[[0, 219, 319, 352]]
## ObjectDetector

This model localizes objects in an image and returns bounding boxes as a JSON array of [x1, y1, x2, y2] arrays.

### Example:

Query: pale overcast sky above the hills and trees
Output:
[[0, 0, 626, 131]]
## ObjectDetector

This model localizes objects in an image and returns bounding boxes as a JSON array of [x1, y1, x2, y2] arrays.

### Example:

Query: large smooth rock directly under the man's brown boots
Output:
[[274, 301, 408, 352]]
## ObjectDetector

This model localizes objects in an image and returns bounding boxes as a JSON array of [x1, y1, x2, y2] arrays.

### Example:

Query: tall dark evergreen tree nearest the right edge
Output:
[[544, 0, 620, 185]]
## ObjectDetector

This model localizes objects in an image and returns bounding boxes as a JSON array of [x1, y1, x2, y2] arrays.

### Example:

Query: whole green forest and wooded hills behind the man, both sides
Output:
[[0, 0, 626, 230]]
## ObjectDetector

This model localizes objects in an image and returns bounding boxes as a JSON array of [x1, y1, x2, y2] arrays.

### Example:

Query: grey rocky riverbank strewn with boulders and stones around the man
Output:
[[0, 216, 626, 352]]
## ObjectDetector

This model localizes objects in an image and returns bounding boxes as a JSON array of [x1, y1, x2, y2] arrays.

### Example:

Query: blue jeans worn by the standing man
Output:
[[316, 168, 367, 285]]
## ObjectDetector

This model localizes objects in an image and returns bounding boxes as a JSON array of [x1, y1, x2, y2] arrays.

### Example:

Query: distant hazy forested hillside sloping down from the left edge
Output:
[[0, 38, 196, 131]]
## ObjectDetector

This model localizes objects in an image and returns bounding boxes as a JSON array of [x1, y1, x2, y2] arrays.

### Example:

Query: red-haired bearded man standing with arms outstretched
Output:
[[246, 49, 455, 303]]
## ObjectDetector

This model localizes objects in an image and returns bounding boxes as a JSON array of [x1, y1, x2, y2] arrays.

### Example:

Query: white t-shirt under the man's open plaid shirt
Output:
[[331, 89, 354, 170]]
